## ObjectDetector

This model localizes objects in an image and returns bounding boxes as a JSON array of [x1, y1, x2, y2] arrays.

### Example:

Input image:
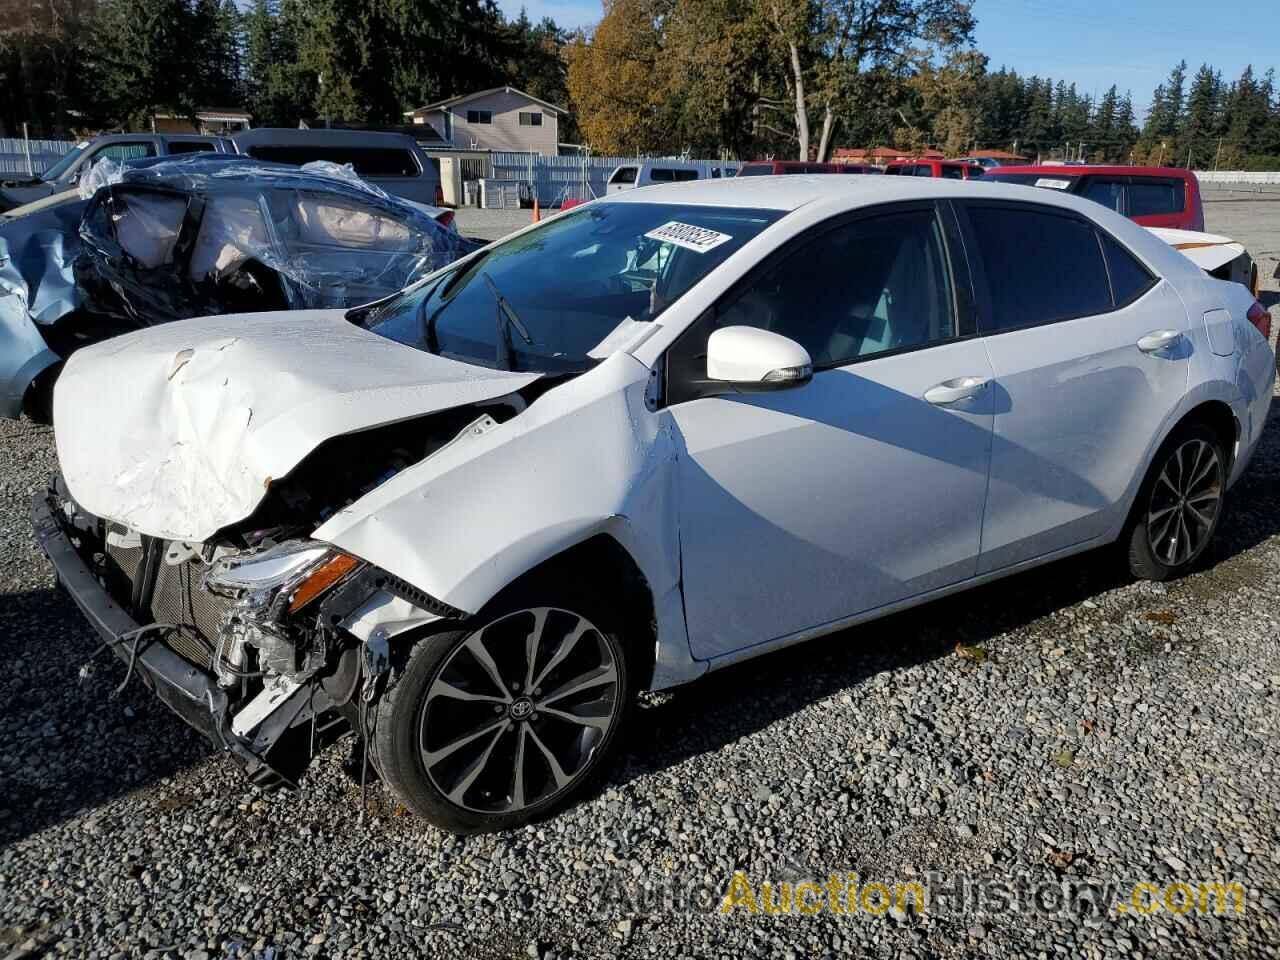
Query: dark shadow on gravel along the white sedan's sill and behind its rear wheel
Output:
[[627, 404, 1280, 780]]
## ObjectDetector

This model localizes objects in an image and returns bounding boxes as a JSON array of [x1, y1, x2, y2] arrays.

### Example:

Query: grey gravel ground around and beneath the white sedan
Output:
[[0, 204, 1280, 960]]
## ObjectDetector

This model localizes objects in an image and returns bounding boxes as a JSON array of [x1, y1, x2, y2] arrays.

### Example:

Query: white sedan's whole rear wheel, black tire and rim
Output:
[[1121, 422, 1230, 581]]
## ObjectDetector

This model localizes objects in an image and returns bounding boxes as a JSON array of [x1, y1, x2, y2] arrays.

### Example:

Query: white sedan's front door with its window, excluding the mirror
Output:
[[666, 204, 993, 659]]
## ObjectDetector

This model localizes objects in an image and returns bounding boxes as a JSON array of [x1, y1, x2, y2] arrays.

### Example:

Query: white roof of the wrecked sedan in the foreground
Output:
[[596, 174, 1126, 218]]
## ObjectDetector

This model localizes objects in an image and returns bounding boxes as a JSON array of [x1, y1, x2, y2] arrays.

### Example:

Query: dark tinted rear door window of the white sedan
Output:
[[969, 206, 1111, 333]]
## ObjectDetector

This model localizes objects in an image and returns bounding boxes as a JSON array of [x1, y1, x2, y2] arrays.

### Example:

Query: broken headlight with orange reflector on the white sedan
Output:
[[205, 540, 360, 613]]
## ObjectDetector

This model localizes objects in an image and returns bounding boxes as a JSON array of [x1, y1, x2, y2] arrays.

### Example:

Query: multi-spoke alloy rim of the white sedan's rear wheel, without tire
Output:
[[1147, 438, 1224, 567]]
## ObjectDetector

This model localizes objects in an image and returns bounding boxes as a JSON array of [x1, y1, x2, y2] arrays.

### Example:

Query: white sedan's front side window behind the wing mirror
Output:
[[668, 210, 956, 403]]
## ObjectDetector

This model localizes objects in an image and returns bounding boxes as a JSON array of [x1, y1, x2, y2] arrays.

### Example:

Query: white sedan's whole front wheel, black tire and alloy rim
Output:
[[374, 603, 632, 833]]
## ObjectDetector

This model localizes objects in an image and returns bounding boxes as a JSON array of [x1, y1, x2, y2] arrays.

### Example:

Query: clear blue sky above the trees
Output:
[[498, 0, 1280, 114]]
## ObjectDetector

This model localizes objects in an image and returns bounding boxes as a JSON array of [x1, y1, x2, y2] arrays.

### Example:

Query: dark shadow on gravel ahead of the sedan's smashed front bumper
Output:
[[0, 589, 212, 845]]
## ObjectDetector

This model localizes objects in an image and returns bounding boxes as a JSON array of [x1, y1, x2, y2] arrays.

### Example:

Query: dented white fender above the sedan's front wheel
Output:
[[314, 352, 701, 687]]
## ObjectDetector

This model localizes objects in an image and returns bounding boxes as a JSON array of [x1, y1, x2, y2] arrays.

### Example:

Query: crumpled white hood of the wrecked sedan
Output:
[[54, 310, 539, 543]]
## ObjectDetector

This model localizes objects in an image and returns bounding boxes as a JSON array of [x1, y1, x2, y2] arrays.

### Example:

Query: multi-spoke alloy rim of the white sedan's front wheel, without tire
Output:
[[419, 607, 622, 814]]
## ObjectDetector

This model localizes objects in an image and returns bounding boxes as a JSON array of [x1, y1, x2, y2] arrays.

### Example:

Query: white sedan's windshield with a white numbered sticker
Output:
[[365, 204, 782, 372]]
